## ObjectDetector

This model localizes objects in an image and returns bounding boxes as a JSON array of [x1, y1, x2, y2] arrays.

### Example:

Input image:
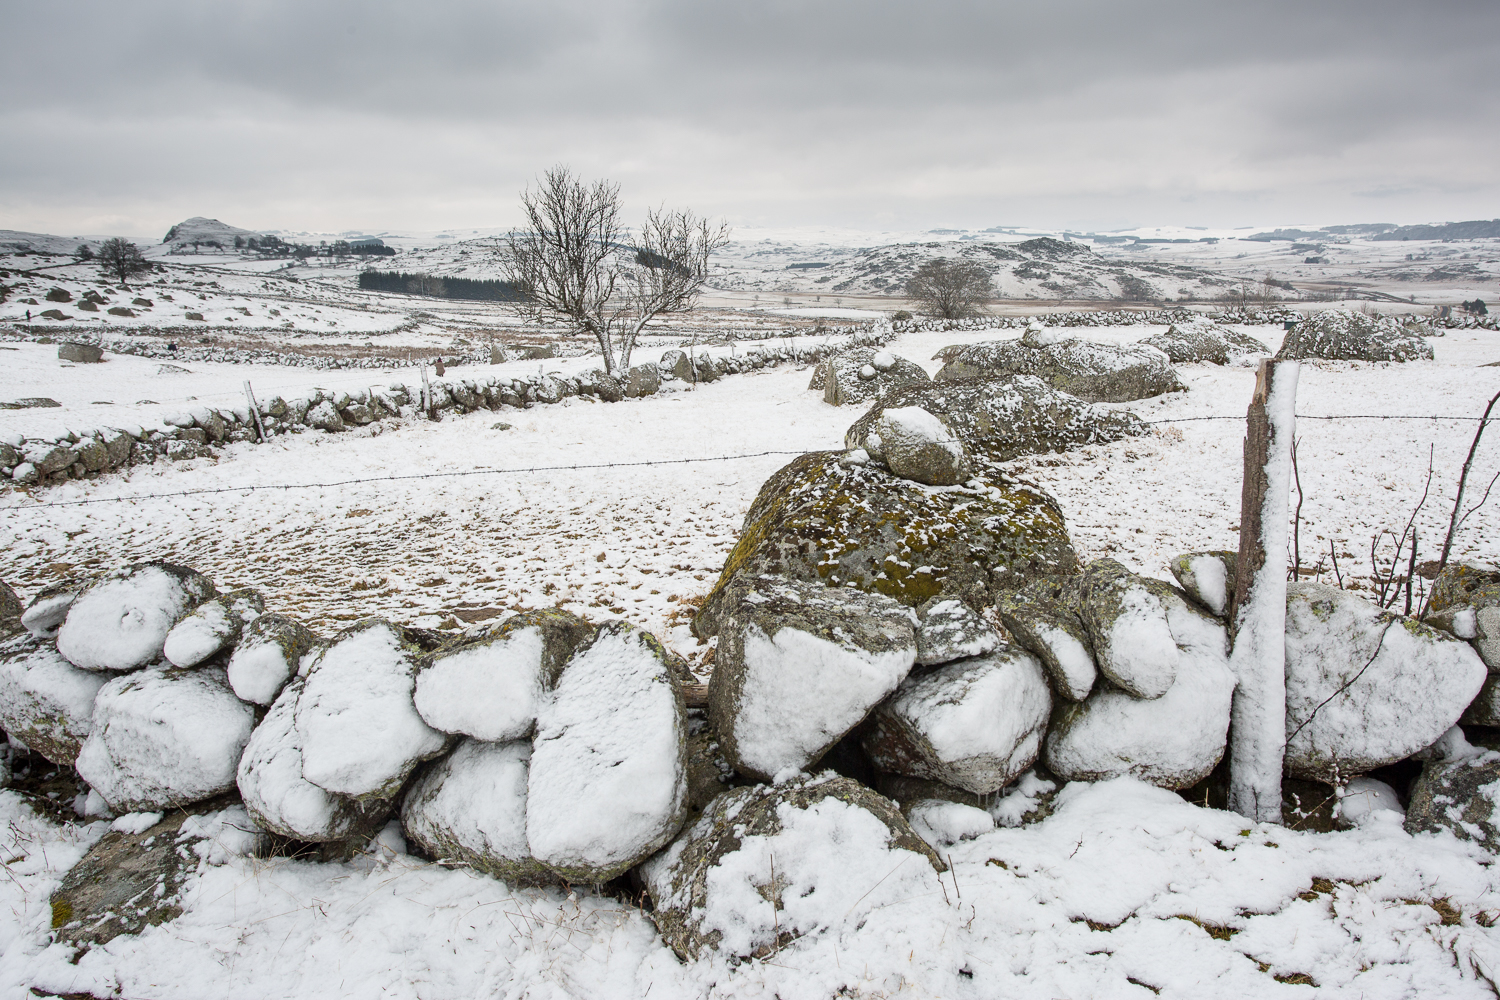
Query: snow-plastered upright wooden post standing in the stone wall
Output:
[[1229, 361, 1302, 822]]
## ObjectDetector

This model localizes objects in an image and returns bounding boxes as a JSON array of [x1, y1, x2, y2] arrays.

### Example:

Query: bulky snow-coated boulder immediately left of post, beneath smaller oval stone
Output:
[[1046, 595, 1235, 789]]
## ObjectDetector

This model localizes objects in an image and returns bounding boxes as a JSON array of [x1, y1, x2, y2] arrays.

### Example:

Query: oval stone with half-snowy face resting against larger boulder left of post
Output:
[[1079, 559, 1178, 699]]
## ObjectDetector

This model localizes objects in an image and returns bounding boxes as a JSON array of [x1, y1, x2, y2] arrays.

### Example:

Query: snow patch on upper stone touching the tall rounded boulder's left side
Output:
[[414, 625, 548, 742]]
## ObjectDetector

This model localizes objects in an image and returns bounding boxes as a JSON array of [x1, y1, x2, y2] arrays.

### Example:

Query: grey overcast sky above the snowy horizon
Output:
[[0, 0, 1500, 238]]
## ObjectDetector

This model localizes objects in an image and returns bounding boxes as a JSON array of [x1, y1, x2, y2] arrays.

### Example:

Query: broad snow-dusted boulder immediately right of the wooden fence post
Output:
[[1286, 582, 1488, 781]]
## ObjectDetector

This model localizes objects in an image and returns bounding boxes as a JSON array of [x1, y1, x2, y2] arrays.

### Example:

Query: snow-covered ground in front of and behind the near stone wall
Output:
[[0, 320, 1500, 1000]]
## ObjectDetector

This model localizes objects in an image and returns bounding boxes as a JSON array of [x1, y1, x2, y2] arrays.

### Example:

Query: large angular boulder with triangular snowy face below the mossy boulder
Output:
[[708, 577, 917, 780]]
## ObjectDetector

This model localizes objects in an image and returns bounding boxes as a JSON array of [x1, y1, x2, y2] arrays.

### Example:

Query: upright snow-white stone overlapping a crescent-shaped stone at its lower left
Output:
[[296, 618, 447, 801]]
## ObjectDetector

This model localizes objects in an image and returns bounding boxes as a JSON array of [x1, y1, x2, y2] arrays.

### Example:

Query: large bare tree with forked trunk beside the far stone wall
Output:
[[506, 166, 729, 373]]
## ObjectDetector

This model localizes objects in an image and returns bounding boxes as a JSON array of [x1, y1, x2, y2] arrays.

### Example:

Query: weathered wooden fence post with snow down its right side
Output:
[[1229, 358, 1299, 823]]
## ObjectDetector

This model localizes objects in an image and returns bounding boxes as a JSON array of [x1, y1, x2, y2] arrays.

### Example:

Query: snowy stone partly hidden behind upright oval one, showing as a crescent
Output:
[[236, 679, 392, 843]]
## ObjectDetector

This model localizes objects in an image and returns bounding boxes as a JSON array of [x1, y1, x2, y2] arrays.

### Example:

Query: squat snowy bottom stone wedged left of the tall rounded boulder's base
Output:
[[401, 739, 557, 886]]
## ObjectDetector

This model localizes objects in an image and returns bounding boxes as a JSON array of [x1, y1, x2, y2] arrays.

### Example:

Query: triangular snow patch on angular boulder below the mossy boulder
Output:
[[734, 625, 917, 774]]
